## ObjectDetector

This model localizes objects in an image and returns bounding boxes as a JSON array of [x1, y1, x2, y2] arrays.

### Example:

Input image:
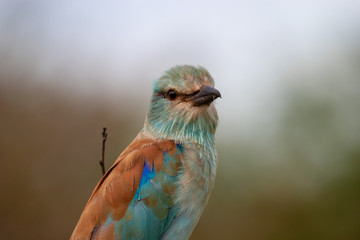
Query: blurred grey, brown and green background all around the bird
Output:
[[0, 0, 360, 240]]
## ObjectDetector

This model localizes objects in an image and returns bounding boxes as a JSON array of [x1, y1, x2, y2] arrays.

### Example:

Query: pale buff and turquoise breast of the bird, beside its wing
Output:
[[156, 144, 216, 240]]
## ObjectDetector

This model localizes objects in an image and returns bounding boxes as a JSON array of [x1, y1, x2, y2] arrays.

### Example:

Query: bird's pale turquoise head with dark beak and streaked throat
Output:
[[144, 65, 221, 143]]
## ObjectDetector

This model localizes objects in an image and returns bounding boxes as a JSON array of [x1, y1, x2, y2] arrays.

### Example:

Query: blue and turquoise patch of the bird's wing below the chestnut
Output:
[[101, 144, 183, 240]]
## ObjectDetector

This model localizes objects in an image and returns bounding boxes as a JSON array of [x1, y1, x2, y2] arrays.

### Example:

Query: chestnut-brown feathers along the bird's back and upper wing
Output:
[[70, 139, 176, 240]]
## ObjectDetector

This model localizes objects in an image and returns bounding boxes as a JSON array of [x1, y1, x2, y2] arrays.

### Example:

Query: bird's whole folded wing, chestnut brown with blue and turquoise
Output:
[[71, 138, 182, 239]]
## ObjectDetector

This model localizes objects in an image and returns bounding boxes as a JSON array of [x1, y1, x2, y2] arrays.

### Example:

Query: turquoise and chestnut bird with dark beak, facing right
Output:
[[70, 65, 221, 240]]
